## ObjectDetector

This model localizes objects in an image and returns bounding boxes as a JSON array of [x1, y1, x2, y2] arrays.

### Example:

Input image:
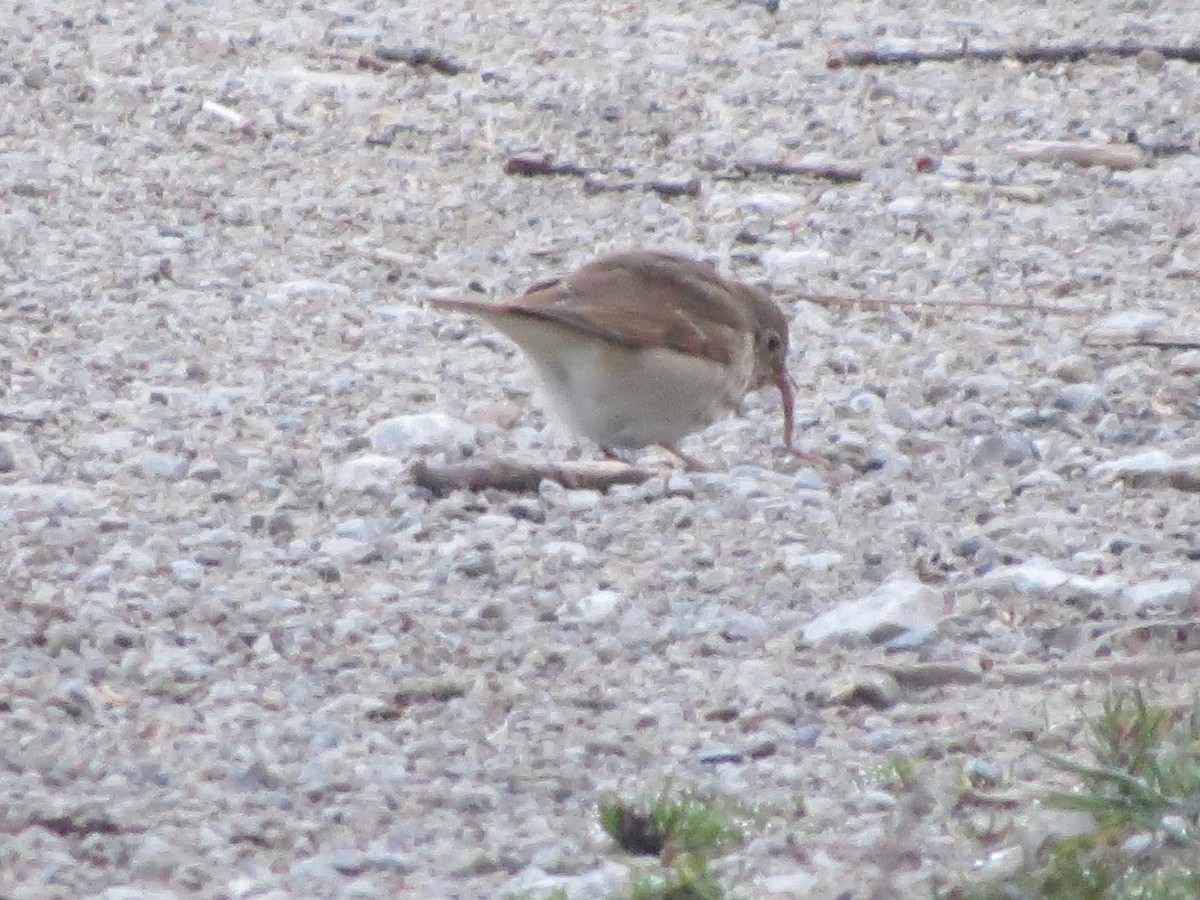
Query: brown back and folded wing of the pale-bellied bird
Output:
[[503, 253, 754, 364]]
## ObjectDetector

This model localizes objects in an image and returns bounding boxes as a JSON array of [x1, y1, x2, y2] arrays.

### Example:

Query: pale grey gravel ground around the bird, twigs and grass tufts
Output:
[[0, 0, 1200, 900]]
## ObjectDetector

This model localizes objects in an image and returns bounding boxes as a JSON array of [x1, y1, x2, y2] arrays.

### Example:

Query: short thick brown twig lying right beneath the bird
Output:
[[412, 460, 656, 497]]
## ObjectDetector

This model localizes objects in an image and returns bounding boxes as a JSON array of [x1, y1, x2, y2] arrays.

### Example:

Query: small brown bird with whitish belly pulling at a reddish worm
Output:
[[431, 251, 817, 470]]
